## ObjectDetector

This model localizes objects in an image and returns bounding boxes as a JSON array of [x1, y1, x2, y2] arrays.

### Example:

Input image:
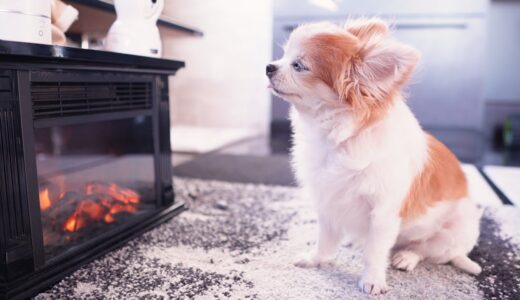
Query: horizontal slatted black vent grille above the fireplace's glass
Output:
[[31, 82, 152, 120]]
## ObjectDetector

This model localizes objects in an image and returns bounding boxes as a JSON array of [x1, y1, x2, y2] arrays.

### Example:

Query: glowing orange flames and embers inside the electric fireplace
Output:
[[40, 183, 141, 232]]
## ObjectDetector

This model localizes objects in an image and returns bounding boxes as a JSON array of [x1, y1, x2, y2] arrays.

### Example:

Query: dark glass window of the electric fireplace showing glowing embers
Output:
[[35, 116, 157, 259]]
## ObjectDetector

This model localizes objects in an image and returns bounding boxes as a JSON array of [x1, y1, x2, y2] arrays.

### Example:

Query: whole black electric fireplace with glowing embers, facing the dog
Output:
[[0, 41, 184, 298]]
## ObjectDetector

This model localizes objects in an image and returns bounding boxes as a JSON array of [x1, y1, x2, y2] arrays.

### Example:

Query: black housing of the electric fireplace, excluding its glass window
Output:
[[0, 40, 184, 299]]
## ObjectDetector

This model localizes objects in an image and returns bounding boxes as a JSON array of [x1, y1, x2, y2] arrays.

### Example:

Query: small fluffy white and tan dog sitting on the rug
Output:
[[266, 19, 481, 294]]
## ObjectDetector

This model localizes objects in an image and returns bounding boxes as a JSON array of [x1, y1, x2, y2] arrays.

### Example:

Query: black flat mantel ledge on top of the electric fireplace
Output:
[[0, 40, 185, 75]]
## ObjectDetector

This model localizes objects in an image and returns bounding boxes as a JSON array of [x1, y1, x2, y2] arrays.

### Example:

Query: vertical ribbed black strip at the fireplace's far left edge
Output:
[[0, 72, 27, 243]]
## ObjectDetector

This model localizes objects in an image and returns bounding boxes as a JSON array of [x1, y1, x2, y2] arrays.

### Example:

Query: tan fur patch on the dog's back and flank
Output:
[[400, 134, 468, 220]]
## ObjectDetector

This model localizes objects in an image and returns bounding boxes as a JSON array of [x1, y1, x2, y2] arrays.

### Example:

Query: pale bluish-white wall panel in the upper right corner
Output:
[[485, 1, 520, 102]]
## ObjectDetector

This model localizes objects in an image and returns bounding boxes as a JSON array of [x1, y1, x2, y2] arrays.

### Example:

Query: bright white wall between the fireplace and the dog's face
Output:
[[161, 0, 272, 133]]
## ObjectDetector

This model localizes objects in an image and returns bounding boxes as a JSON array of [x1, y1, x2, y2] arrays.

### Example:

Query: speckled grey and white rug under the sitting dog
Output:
[[36, 178, 520, 299]]
